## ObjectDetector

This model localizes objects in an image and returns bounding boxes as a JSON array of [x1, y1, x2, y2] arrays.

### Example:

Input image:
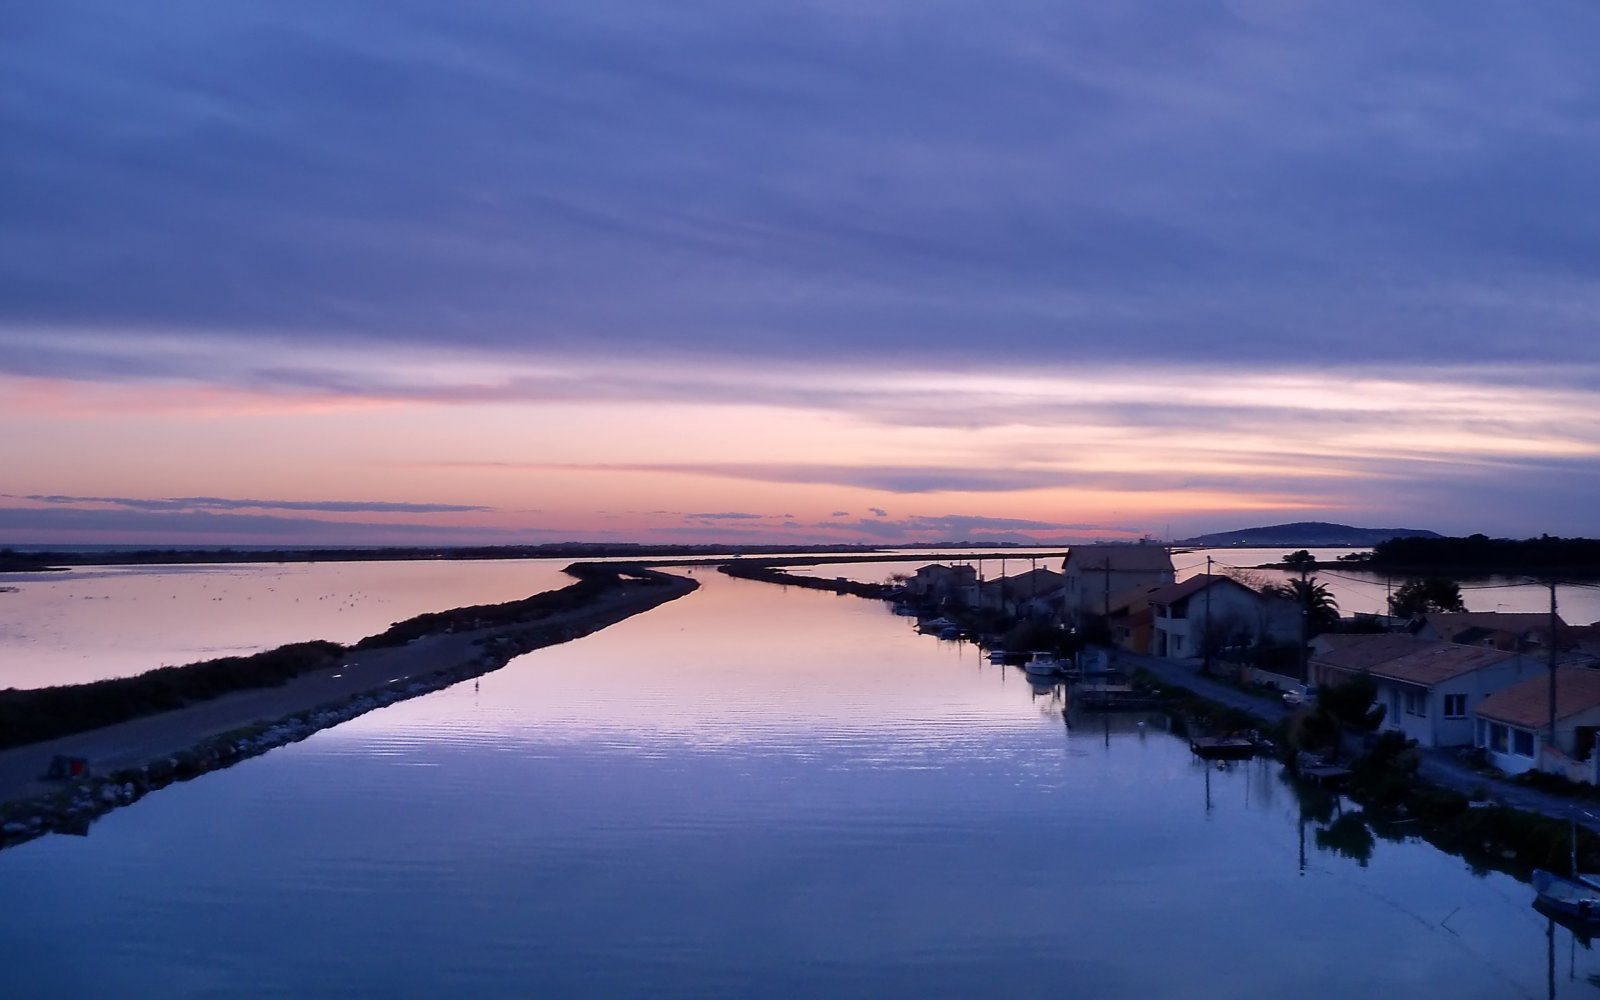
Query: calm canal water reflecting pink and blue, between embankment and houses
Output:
[[0, 573, 1600, 1000]]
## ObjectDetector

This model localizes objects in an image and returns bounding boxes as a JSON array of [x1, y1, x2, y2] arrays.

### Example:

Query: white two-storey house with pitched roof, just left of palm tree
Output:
[[1146, 574, 1299, 659]]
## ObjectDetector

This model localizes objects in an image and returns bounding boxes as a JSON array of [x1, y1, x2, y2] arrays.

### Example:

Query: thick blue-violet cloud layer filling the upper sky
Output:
[[0, 0, 1600, 374]]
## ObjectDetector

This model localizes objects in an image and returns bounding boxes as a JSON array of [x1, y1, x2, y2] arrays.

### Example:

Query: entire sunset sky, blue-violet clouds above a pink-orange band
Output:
[[0, 0, 1600, 544]]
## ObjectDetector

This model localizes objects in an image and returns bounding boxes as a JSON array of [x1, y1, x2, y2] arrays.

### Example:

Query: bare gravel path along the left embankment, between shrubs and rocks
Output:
[[0, 574, 696, 842]]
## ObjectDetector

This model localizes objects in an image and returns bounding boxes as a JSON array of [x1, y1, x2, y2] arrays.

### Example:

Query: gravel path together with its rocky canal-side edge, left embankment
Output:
[[0, 563, 699, 850]]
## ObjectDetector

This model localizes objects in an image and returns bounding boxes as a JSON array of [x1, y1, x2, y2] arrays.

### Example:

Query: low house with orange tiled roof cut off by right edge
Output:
[[1472, 664, 1600, 784]]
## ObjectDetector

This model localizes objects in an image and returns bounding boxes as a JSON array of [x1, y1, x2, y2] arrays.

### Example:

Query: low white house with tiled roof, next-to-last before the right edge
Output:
[[1310, 635, 1542, 747]]
